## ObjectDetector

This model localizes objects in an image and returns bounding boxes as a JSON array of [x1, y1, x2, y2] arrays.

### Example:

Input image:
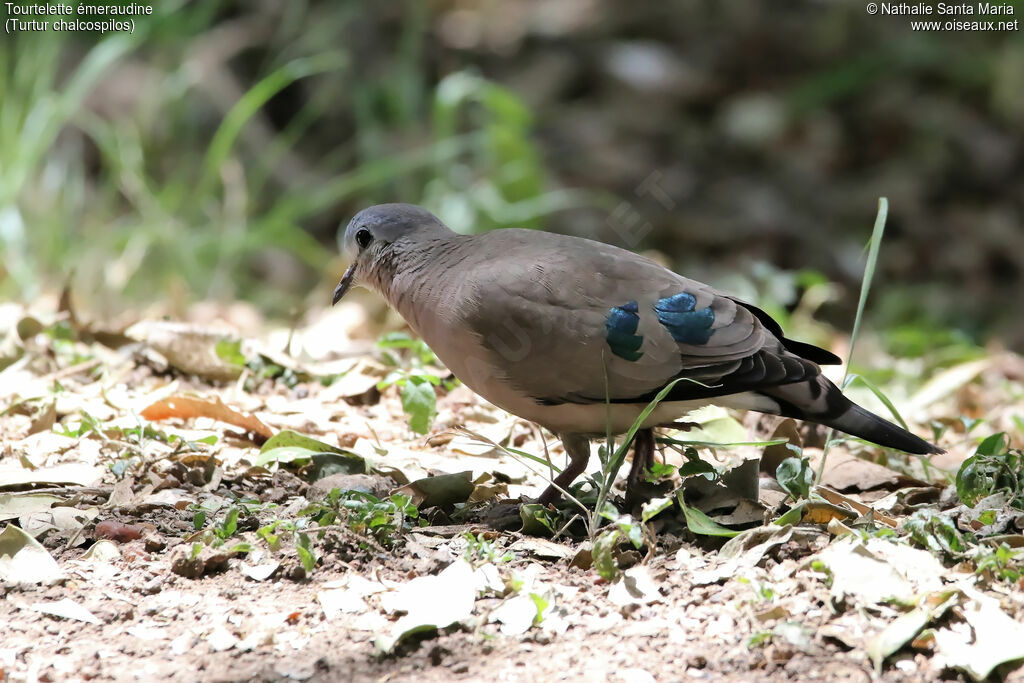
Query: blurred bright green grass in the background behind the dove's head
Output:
[[0, 2, 581, 311]]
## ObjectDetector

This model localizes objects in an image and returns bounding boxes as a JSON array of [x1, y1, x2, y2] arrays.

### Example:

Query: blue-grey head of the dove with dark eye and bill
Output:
[[332, 204, 451, 303]]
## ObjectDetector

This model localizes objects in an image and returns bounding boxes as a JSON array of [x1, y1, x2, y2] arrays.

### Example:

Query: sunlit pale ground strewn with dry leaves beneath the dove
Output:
[[0, 307, 1024, 683]]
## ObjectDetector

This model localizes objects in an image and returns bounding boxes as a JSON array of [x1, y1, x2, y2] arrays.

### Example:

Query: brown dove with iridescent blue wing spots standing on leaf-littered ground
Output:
[[333, 204, 942, 504]]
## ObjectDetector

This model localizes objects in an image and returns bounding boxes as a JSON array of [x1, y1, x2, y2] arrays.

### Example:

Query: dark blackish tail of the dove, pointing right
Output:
[[761, 375, 943, 456]]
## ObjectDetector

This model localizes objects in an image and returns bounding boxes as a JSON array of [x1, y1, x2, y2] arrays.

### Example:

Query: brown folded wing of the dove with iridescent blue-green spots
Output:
[[455, 230, 838, 404]]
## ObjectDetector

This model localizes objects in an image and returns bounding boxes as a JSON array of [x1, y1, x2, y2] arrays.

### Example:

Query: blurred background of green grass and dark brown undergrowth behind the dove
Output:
[[0, 0, 1024, 355]]
